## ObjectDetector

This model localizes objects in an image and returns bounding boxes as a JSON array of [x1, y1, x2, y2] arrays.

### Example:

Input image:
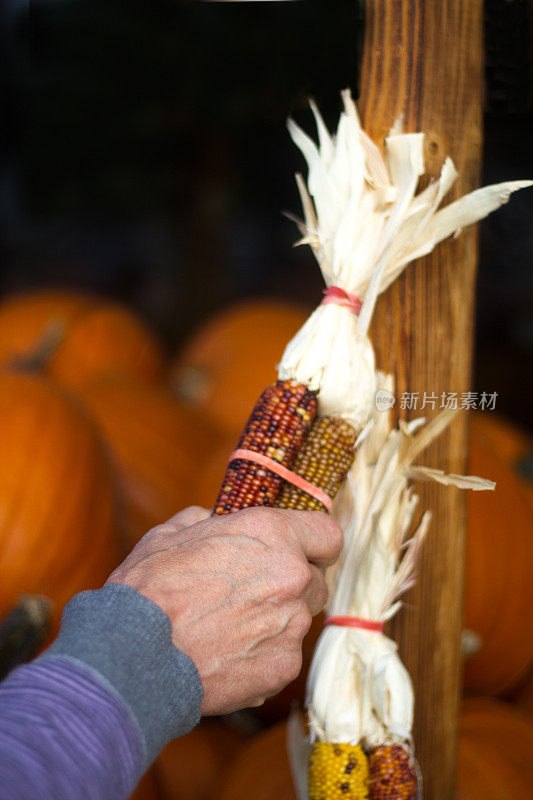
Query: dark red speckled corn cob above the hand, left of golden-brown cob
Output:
[[214, 380, 316, 514]]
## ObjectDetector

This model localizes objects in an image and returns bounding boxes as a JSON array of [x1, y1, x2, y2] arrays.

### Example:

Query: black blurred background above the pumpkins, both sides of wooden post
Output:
[[0, 0, 533, 427]]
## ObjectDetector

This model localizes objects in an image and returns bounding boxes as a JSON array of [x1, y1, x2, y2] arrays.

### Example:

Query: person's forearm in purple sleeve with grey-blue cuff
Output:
[[0, 584, 202, 800]]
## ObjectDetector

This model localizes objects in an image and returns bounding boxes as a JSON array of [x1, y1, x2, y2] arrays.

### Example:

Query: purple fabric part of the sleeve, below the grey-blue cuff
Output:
[[0, 658, 144, 800]]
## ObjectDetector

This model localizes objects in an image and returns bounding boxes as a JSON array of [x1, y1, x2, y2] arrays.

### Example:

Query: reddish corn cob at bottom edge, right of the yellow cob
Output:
[[368, 744, 418, 800]]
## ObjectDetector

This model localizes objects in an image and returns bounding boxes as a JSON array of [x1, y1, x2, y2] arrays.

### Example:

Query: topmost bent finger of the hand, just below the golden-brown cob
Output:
[[283, 511, 342, 567]]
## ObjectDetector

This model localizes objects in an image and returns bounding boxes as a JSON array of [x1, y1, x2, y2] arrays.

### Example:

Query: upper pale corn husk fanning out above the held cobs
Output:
[[278, 91, 532, 430]]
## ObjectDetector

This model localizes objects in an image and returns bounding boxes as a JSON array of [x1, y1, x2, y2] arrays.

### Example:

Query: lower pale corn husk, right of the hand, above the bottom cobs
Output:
[[307, 388, 494, 746]]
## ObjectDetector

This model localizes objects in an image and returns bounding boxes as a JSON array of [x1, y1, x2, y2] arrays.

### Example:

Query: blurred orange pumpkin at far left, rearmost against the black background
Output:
[[0, 291, 163, 387]]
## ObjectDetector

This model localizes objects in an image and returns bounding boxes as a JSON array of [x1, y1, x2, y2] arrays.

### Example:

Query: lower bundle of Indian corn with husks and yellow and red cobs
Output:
[[289, 374, 494, 800]]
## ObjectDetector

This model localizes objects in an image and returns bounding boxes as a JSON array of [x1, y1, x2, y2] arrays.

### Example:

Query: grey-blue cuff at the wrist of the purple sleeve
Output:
[[39, 583, 203, 768]]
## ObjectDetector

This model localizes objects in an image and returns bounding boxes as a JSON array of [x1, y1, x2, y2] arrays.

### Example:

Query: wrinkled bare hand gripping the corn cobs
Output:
[[109, 506, 342, 714]]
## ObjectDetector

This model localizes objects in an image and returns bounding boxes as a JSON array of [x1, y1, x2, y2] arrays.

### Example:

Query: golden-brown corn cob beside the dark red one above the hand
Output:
[[274, 417, 356, 511]]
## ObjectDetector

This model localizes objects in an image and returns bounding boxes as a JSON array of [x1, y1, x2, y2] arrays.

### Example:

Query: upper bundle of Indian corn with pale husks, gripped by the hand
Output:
[[214, 92, 531, 797]]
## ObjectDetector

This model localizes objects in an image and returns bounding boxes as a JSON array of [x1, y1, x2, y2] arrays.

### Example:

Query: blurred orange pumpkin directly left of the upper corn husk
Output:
[[170, 300, 309, 435]]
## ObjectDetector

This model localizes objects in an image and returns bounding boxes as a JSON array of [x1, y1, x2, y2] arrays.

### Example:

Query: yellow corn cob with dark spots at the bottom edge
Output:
[[308, 742, 368, 800]]
